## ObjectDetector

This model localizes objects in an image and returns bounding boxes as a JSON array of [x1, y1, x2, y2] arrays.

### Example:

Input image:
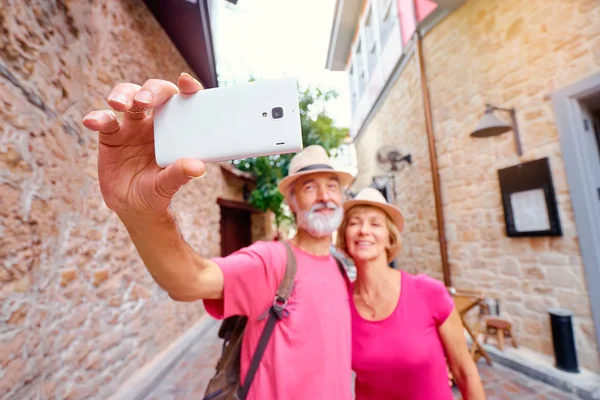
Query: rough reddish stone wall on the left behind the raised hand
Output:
[[0, 0, 260, 399]]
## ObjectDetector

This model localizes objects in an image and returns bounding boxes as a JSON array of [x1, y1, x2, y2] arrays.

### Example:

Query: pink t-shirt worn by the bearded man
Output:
[[204, 242, 352, 400]]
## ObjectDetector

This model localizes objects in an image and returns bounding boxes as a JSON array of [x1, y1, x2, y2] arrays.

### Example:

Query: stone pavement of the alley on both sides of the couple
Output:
[[144, 323, 577, 400]]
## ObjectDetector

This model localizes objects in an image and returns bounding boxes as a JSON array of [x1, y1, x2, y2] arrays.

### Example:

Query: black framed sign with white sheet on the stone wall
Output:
[[498, 158, 562, 237]]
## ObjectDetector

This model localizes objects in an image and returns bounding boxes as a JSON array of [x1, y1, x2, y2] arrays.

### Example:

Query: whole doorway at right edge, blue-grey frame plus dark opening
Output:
[[552, 73, 600, 354]]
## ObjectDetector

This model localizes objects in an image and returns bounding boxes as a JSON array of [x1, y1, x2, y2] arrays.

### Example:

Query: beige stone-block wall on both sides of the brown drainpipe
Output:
[[357, 0, 600, 372]]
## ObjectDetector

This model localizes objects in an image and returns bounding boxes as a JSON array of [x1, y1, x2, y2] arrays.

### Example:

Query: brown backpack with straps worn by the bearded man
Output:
[[204, 240, 348, 400]]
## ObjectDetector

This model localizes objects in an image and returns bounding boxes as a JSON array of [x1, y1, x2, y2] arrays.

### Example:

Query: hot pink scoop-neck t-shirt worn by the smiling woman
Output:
[[350, 272, 454, 400]]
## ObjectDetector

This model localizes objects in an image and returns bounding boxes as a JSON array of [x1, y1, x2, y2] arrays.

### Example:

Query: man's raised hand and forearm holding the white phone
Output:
[[83, 74, 223, 301]]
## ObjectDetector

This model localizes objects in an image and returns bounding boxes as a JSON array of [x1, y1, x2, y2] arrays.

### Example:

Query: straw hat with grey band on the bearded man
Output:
[[278, 144, 354, 197]]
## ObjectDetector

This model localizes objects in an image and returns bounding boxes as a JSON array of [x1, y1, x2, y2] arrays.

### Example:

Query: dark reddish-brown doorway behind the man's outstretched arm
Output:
[[217, 199, 254, 257]]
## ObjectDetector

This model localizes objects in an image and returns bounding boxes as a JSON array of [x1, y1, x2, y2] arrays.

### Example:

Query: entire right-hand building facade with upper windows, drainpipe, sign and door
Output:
[[327, 0, 600, 372]]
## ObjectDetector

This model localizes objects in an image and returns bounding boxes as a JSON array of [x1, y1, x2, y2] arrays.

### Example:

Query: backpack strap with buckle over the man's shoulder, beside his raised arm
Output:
[[239, 240, 296, 400]]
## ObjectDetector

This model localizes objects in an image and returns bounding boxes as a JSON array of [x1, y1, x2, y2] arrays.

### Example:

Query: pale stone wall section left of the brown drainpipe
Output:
[[351, 57, 443, 279]]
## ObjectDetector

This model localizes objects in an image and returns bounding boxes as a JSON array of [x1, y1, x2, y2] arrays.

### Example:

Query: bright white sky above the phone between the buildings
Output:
[[213, 0, 351, 127]]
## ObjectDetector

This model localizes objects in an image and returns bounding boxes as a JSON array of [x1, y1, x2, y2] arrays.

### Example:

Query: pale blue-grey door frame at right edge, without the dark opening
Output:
[[552, 73, 600, 352]]
